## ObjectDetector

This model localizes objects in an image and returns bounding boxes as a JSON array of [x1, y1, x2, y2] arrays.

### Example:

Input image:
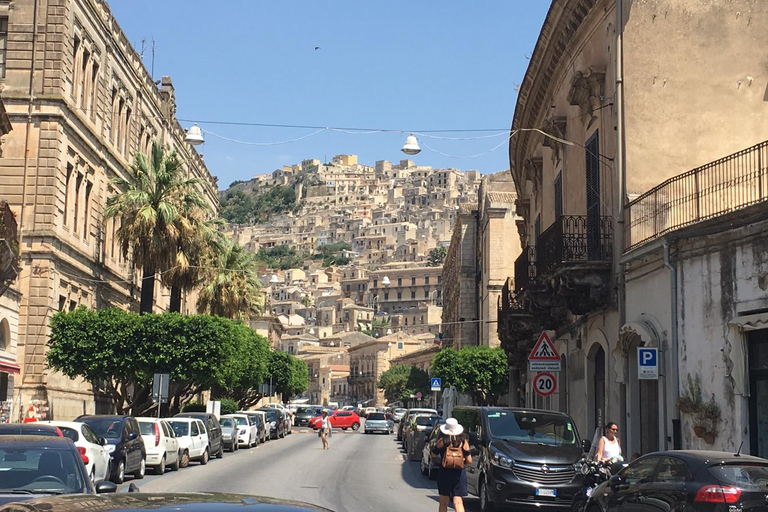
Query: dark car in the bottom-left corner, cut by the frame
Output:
[[0, 435, 117, 505]]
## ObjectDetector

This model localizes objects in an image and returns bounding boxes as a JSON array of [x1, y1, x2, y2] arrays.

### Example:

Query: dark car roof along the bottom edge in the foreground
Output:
[[0, 492, 331, 512]]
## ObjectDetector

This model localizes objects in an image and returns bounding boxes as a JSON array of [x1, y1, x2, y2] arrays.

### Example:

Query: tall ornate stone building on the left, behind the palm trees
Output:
[[0, 0, 218, 419]]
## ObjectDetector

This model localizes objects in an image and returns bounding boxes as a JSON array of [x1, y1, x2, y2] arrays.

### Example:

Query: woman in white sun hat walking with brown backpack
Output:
[[434, 418, 472, 512]]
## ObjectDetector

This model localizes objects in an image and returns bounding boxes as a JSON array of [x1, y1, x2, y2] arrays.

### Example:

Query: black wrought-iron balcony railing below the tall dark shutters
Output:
[[536, 215, 613, 276]]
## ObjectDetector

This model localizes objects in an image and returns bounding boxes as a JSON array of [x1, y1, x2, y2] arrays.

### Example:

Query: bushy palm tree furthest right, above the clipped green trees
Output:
[[197, 242, 264, 319]]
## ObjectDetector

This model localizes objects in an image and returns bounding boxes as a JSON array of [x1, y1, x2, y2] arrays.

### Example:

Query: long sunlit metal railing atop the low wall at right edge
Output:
[[624, 141, 768, 250]]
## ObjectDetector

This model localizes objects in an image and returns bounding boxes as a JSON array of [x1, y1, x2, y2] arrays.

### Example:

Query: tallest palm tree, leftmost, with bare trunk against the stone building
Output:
[[104, 142, 205, 313]]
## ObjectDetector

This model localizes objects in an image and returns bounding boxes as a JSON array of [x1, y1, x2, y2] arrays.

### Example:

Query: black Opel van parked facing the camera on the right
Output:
[[453, 406, 589, 511]]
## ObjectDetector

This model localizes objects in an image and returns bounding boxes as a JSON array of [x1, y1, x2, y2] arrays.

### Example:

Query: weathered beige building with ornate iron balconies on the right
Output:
[[500, 0, 768, 453]]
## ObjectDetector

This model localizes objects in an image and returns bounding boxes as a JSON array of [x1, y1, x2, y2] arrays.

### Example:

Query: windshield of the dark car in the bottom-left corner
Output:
[[0, 444, 88, 494]]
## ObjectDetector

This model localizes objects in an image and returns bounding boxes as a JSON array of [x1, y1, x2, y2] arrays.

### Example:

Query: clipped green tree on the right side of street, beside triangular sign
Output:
[[432, 347, 509, 405]]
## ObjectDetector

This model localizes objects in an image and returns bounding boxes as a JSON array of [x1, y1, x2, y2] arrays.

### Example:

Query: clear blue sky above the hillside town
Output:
[[109, 0, 550, 188]]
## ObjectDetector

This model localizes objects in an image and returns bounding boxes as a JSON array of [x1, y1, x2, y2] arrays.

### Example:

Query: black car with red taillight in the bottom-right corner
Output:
[[586, 450, 768, 512]]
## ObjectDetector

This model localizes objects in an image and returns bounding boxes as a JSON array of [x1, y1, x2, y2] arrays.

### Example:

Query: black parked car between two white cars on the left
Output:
[[75, 414, 147, 484]]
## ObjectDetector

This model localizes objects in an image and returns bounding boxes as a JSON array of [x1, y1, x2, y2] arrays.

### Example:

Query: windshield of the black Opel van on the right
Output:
[[488, 411, 578, 446]]
